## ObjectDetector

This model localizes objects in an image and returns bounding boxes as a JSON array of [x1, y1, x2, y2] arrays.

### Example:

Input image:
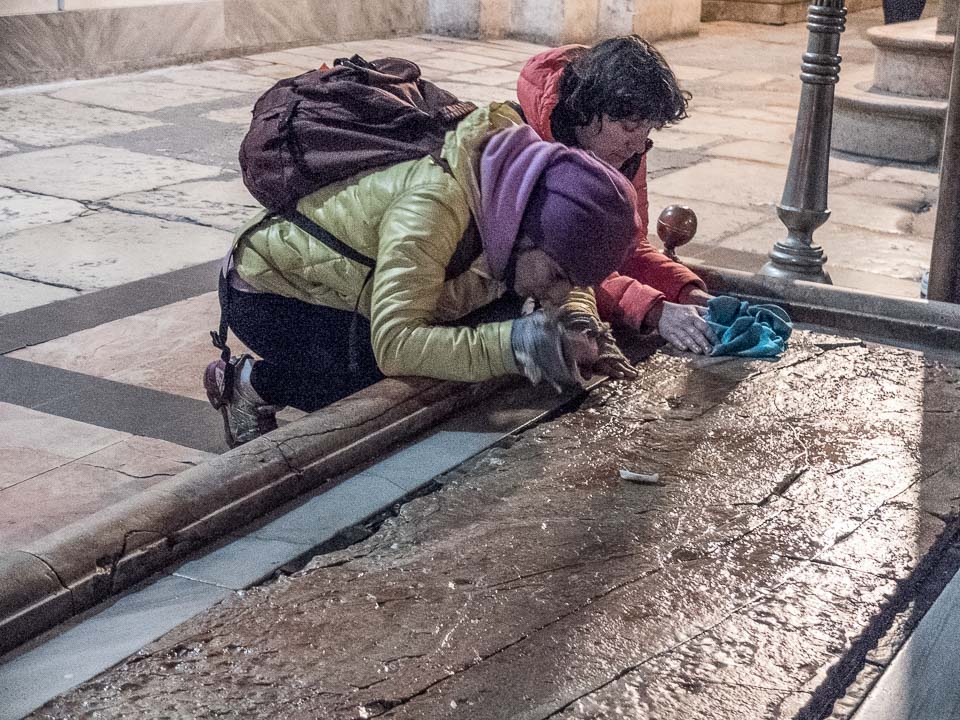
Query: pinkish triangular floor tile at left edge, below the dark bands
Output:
[[0, 402, 130, 490]]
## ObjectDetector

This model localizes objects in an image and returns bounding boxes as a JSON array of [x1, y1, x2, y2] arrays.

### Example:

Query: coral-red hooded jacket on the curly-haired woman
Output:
[[517, 45, 706, 328]]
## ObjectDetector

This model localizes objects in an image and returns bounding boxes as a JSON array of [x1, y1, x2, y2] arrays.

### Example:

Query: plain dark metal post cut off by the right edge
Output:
[[927, 10, 960, 303]]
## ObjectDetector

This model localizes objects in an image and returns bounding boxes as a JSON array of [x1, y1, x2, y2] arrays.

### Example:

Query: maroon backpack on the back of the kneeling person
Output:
[[240, 55, 476, 214]]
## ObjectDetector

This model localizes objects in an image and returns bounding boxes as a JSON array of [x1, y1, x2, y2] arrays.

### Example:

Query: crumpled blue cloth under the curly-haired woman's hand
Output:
[[705, 295, 793, 357]]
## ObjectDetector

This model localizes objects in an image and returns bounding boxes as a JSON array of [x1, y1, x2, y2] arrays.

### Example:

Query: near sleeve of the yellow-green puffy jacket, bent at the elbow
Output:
[[370, 183, 519, 382]]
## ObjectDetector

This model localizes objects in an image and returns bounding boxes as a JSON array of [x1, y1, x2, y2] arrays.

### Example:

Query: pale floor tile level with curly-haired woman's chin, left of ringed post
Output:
[[649, 158, 785, 208]]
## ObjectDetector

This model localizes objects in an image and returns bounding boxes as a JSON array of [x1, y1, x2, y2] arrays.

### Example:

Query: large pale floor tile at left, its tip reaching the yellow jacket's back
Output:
[[0, 208, 232, 290]]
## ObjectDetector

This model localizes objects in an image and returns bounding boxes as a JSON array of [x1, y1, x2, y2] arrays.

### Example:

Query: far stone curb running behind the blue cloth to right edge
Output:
[[686, 262, 960, 350]]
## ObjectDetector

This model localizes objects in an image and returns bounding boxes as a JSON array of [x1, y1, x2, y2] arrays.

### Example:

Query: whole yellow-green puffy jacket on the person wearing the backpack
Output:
[[233, 103, 522, 381]]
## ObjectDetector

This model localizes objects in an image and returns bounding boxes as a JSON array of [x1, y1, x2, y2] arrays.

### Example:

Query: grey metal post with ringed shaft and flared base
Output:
[[760, 0, 847, 283]]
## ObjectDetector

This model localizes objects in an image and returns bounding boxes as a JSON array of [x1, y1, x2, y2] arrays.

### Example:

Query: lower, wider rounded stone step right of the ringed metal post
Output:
[[831, 67, 947, 164]]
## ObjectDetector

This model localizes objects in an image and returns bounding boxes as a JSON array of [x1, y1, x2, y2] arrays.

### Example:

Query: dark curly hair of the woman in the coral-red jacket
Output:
[[550, 35, 691, 146]]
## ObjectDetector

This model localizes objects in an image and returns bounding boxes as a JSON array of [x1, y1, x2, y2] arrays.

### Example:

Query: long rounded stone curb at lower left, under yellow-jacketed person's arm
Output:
[[0, 377, 518, 653]]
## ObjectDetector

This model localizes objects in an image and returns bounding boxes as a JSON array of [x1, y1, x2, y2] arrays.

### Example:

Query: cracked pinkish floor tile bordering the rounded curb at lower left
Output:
[[0, 436, 212, 552]]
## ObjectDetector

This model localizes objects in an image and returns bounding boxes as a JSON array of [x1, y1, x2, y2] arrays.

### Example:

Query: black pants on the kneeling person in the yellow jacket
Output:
[[220, 277, 383, 412]]
